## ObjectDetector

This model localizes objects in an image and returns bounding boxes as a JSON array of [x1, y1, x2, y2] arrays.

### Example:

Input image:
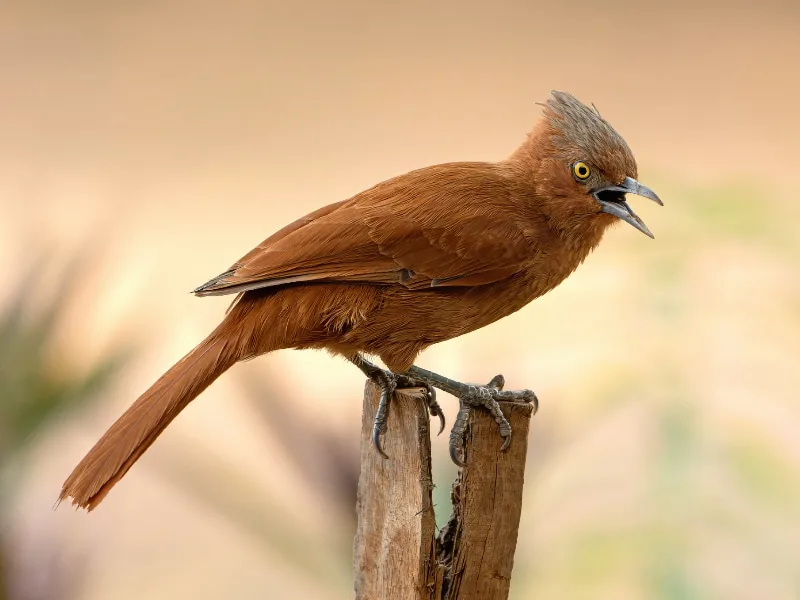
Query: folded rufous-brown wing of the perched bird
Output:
[[195, 163, 533, 296]]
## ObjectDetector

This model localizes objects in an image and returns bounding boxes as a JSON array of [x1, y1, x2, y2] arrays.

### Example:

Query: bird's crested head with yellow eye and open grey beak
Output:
[[528, 92, 663, 237]]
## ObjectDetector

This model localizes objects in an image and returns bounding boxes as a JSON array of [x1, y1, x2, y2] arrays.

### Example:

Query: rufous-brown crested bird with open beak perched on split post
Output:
[[59, 91, 663, 510]]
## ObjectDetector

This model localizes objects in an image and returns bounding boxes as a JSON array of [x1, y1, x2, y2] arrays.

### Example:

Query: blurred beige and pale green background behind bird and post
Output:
[[0, 0, 800, 600]]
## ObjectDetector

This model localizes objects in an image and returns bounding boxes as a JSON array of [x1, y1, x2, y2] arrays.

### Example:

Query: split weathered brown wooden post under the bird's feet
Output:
[[354, 382, 532, 600]]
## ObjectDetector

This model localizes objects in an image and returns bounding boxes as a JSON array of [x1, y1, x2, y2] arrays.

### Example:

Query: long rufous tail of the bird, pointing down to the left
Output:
[[59, 322, 241, 510]]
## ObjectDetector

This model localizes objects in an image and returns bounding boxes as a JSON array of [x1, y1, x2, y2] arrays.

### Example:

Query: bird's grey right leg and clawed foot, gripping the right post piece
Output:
[[406, 366, 539, 467]]
